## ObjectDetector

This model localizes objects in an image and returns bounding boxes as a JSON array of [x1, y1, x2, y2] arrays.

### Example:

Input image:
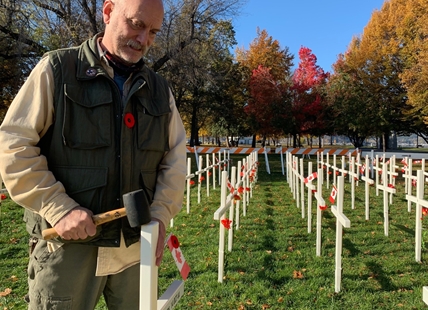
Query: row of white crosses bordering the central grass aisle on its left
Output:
[[214, 152, 258, 283]]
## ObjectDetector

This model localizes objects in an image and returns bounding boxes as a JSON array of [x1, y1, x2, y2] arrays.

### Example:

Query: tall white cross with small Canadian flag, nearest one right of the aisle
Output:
[[331, 176, 351, 293]]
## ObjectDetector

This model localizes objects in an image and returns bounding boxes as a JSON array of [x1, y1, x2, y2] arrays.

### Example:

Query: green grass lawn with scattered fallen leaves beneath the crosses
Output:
[[0, 155, 428, 310]]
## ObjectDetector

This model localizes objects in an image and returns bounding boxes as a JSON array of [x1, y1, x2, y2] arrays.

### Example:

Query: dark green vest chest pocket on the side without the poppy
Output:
[[59, 82, 113, 149]]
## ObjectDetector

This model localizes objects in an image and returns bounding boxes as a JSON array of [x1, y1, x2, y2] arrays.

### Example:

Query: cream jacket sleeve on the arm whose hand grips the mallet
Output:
[[0, 57, 77, 225]]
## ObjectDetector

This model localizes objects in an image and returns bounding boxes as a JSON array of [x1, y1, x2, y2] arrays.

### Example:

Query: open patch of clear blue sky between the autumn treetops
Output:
[[233, 0, 388, 72]]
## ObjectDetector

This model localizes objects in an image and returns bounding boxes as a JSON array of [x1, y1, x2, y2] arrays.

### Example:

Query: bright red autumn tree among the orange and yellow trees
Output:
[[291, 46, 329, 147]]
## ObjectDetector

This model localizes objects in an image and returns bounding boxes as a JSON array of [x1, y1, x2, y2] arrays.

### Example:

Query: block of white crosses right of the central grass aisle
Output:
[[287, 154, 428, 304]]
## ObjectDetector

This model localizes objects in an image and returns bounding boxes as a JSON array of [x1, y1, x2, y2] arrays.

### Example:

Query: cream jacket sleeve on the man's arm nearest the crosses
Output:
[[150, 91, 186, 227]]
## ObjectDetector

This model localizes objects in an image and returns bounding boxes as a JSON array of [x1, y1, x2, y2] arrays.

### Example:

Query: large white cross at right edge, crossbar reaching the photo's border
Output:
[[406, 170, 428, 263]]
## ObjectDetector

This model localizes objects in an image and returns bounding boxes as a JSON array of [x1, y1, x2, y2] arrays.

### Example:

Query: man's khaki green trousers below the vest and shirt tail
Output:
[[28, 240, 140, 310]]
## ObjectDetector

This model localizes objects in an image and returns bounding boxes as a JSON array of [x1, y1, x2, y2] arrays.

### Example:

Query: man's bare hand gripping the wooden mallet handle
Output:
[[54, 207, 97, 240]]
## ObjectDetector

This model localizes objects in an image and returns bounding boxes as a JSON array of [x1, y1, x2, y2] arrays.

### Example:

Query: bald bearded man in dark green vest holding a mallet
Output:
[[0, 0, 186, 310]]
